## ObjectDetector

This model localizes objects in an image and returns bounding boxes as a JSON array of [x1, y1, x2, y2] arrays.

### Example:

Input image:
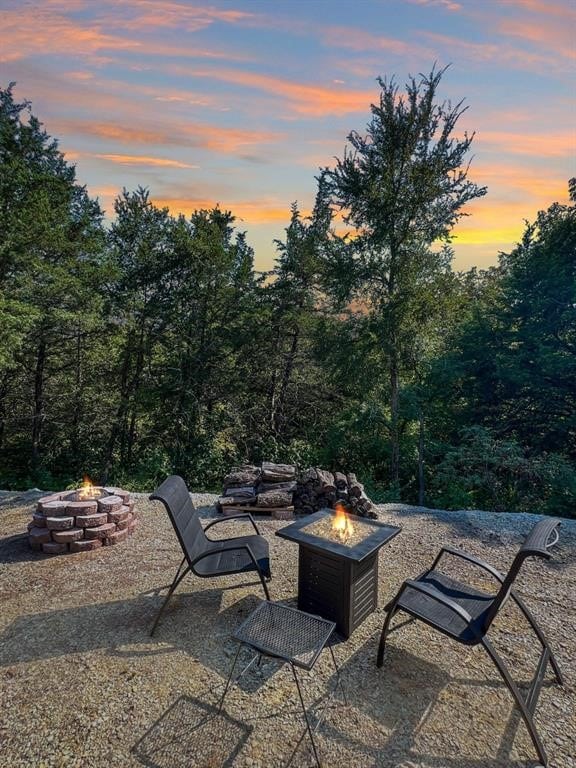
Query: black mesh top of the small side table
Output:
[[234, 602, 336, 669]]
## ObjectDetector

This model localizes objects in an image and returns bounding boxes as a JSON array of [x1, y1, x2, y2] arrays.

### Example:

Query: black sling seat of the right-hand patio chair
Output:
[[397, 570, 494, 645]]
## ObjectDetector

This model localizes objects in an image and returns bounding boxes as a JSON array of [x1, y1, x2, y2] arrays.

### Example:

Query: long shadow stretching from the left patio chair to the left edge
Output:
[[0, 583, 284, 692]]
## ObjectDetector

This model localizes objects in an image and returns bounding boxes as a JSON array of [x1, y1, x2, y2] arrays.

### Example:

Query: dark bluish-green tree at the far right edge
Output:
[[444, 182, 576, 460]]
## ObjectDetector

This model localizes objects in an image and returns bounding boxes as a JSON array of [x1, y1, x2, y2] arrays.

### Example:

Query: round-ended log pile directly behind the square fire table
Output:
[[294, 467, 378, 519]]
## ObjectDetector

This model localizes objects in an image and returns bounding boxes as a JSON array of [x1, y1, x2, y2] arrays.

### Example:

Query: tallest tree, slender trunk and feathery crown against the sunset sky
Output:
[[324, 70, 486, 488]]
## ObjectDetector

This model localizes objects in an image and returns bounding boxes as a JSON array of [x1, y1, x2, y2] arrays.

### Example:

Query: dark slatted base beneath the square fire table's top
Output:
[[298, 544, 378, 638]]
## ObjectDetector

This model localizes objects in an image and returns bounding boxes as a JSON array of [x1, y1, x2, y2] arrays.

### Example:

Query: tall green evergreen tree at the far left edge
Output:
[[0, 84, 104, 480]]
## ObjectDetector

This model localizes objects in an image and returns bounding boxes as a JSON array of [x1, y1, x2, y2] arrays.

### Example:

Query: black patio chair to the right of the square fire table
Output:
[[376, 518, 563, 766]]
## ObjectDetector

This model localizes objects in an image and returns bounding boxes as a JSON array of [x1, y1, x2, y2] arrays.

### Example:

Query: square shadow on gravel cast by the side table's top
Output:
[[131, 696, 253, 768]]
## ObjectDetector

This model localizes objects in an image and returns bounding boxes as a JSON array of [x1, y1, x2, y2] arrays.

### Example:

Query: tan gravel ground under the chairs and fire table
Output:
[[0, 492, 576, 768]]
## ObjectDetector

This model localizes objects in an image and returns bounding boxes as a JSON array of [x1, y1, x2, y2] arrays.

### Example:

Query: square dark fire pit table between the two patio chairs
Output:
[[276, 509, 402, 637]]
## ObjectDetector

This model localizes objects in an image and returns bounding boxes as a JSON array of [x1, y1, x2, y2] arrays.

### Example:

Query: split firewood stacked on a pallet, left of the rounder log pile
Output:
[[218, 461, 296, 519]]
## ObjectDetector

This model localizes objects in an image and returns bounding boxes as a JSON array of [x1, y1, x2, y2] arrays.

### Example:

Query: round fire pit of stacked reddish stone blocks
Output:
[[28, 486, 137, 555]]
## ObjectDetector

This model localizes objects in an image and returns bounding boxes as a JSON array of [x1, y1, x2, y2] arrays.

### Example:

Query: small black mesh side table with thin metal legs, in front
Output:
[[218, 601, 346, 768]]
